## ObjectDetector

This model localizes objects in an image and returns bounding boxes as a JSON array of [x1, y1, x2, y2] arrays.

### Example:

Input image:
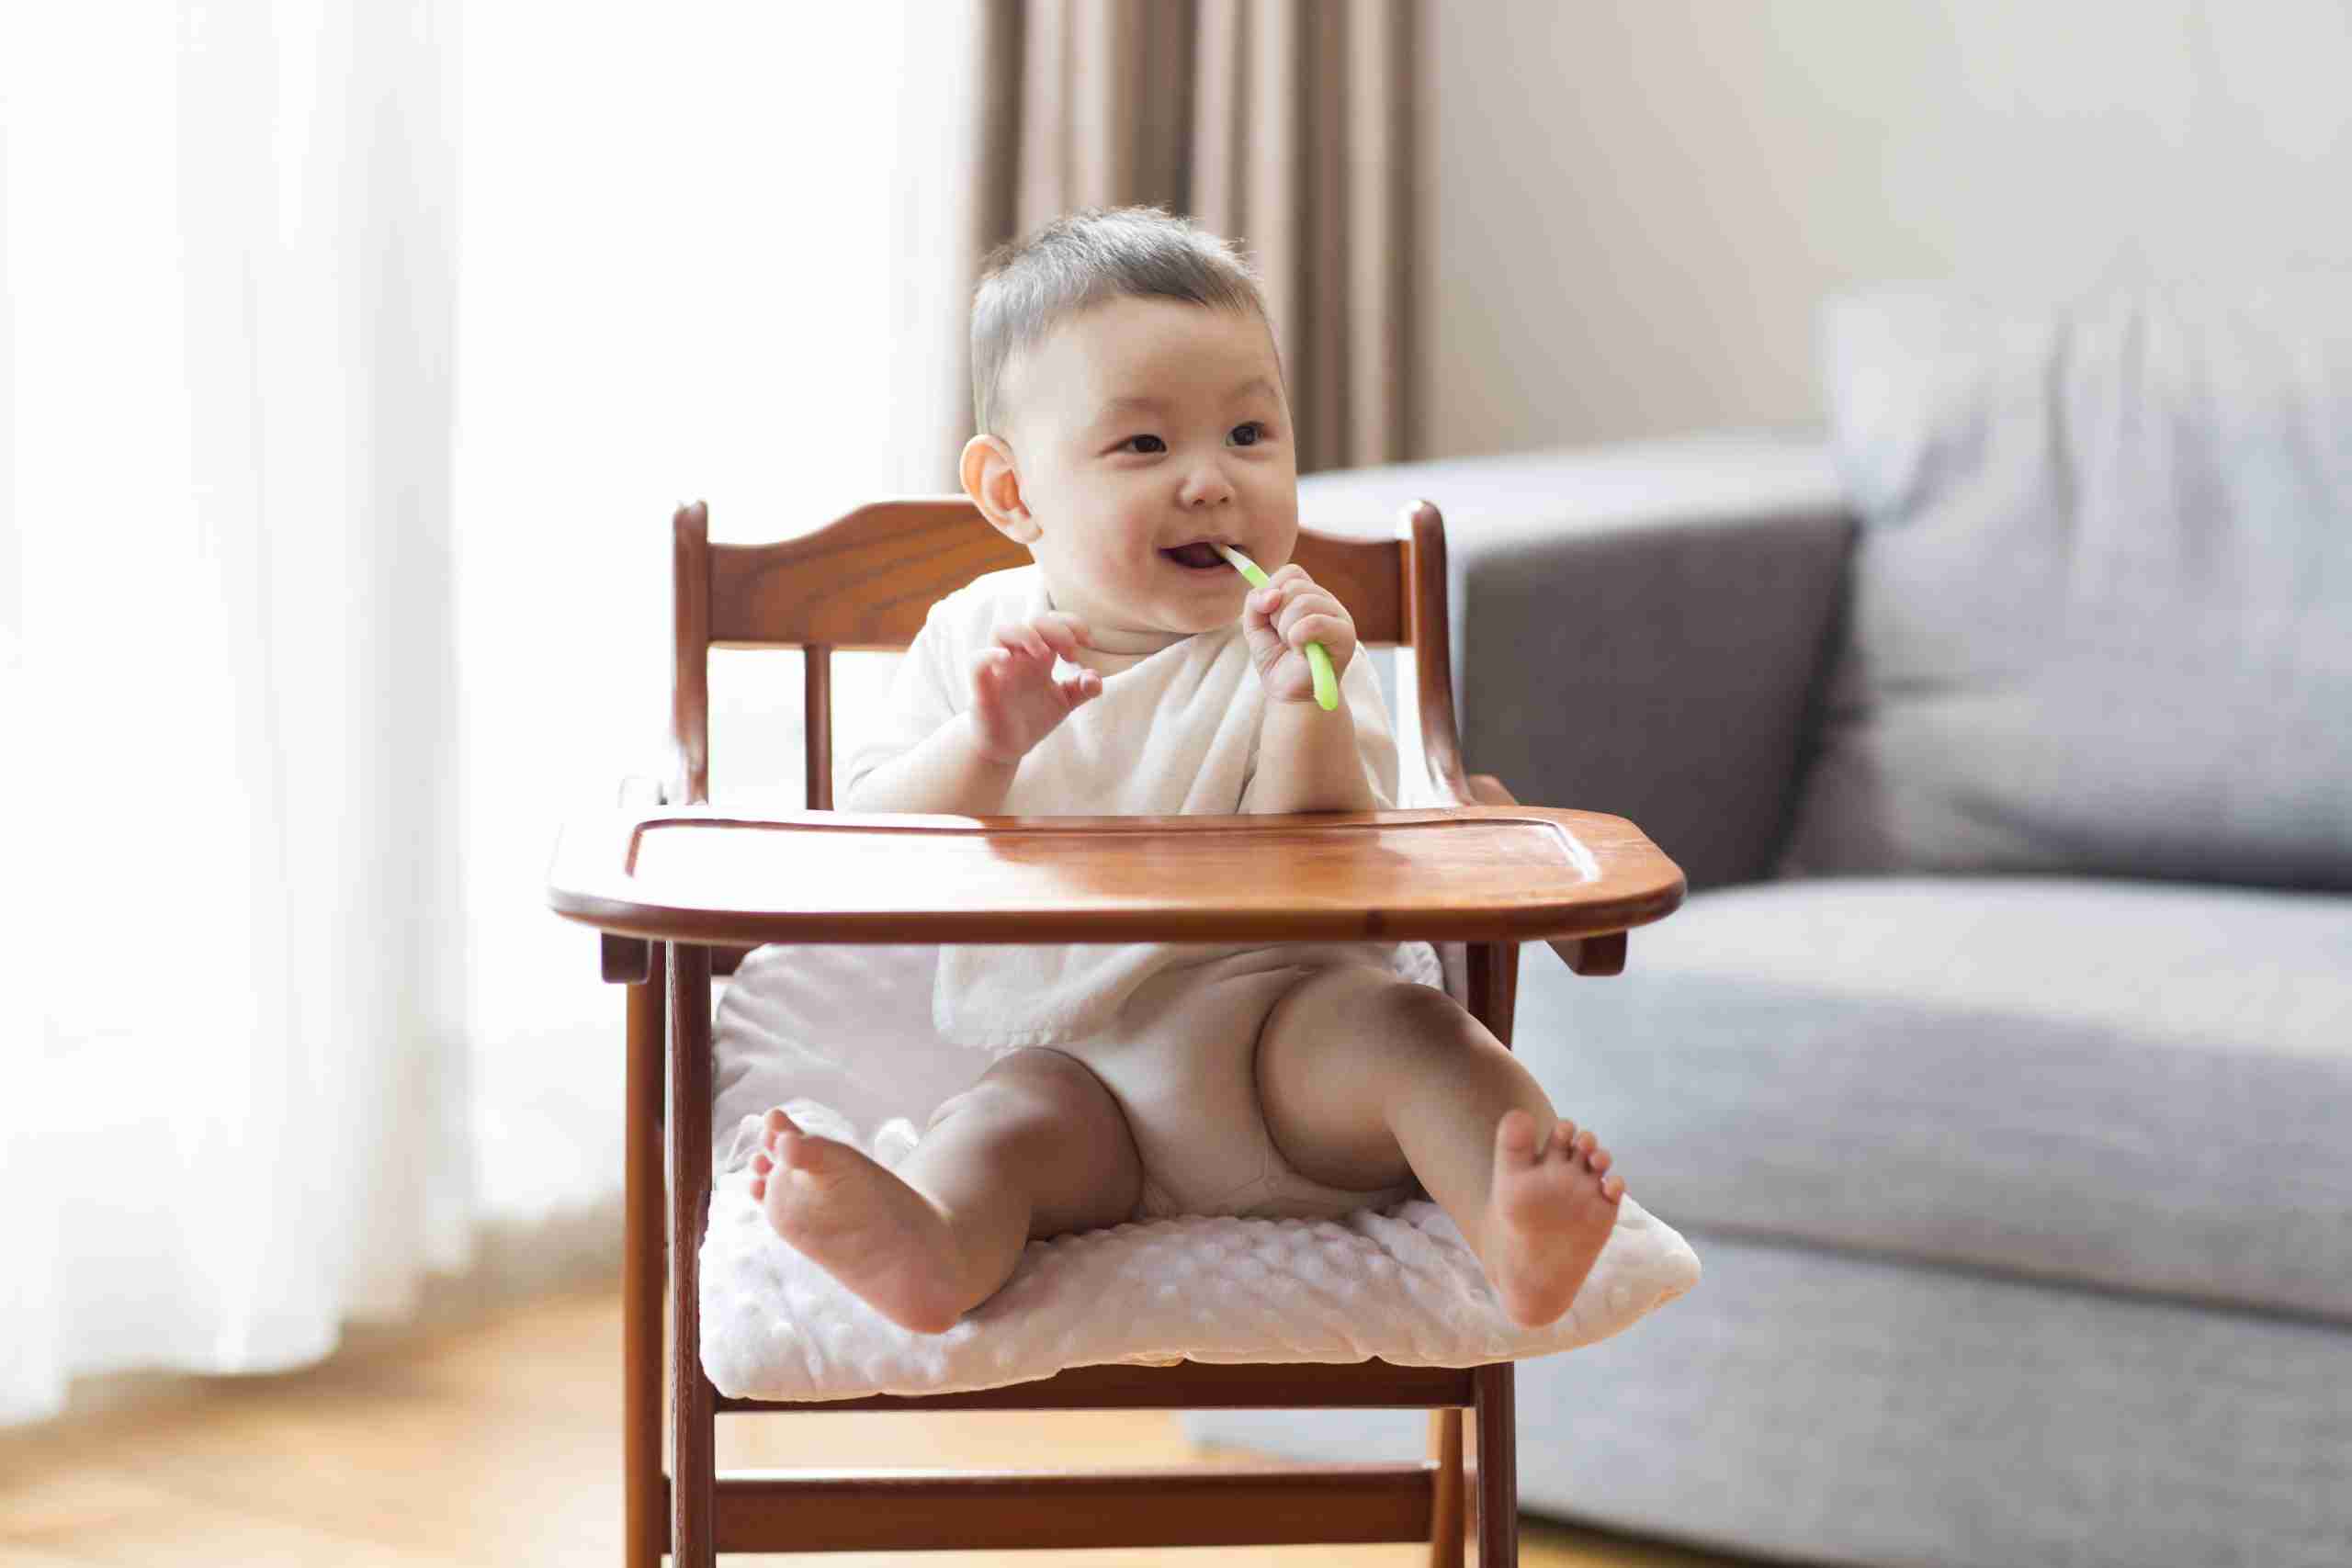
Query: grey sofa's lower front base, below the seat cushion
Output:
[[1183, 1232, 2352, 1568]]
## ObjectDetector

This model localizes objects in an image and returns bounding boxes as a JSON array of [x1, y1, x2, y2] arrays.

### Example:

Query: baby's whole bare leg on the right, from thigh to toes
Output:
[[1259, 966, 1625, 1325]]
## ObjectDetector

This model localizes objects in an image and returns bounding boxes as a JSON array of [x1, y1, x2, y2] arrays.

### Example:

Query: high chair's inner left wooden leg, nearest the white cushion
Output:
[[668, 942, 718, 1568]]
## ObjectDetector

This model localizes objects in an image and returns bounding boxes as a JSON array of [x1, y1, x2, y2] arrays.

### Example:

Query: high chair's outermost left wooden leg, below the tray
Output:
[[621, 942, 671, 1568]]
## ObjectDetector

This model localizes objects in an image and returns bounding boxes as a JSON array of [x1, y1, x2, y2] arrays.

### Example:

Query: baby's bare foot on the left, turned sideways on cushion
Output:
[[751, 1110, 965, 1333]]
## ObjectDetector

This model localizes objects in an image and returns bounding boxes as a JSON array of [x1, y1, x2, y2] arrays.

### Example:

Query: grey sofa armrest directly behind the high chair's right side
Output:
[[1298, 434, 1856, 888]]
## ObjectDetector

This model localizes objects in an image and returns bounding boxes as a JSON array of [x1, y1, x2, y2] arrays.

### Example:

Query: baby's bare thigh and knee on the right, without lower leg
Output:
[[1256, 964, 1500, 1187]]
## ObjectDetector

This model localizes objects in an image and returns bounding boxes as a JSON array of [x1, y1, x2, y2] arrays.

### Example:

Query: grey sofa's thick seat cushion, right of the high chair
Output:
[[1515, 877, 2352, 1321]]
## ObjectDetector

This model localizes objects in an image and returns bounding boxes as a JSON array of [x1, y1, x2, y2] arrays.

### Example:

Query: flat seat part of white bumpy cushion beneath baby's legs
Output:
[[701, 1100, 1698, 1399]]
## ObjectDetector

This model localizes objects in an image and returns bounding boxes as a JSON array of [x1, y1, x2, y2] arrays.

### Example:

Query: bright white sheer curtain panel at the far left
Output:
[[0, 0, 473, 1420]]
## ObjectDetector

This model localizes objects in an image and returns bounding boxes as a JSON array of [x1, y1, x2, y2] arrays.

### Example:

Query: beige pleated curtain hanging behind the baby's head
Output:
[[894, 0, 1416, 489]]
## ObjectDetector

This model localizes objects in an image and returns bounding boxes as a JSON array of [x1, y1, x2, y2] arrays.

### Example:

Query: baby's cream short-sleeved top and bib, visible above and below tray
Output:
[[842, 564, 1440, 1051]]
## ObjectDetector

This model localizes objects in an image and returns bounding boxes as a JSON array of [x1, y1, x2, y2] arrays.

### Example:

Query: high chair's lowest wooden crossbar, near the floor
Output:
[[686, 1462, 1437, 1551]]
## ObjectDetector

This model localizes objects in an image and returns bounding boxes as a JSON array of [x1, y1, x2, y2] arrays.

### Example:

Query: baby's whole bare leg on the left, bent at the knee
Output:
[[752, 1051, 1143, 1333]]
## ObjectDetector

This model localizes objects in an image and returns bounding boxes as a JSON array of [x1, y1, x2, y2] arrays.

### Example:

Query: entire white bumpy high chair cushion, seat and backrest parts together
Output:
[[701, 945, 1698, 1401]]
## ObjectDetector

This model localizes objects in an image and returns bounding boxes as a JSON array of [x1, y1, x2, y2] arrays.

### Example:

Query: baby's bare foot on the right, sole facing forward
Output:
[[1479, 1110, 1625, 1328]]
